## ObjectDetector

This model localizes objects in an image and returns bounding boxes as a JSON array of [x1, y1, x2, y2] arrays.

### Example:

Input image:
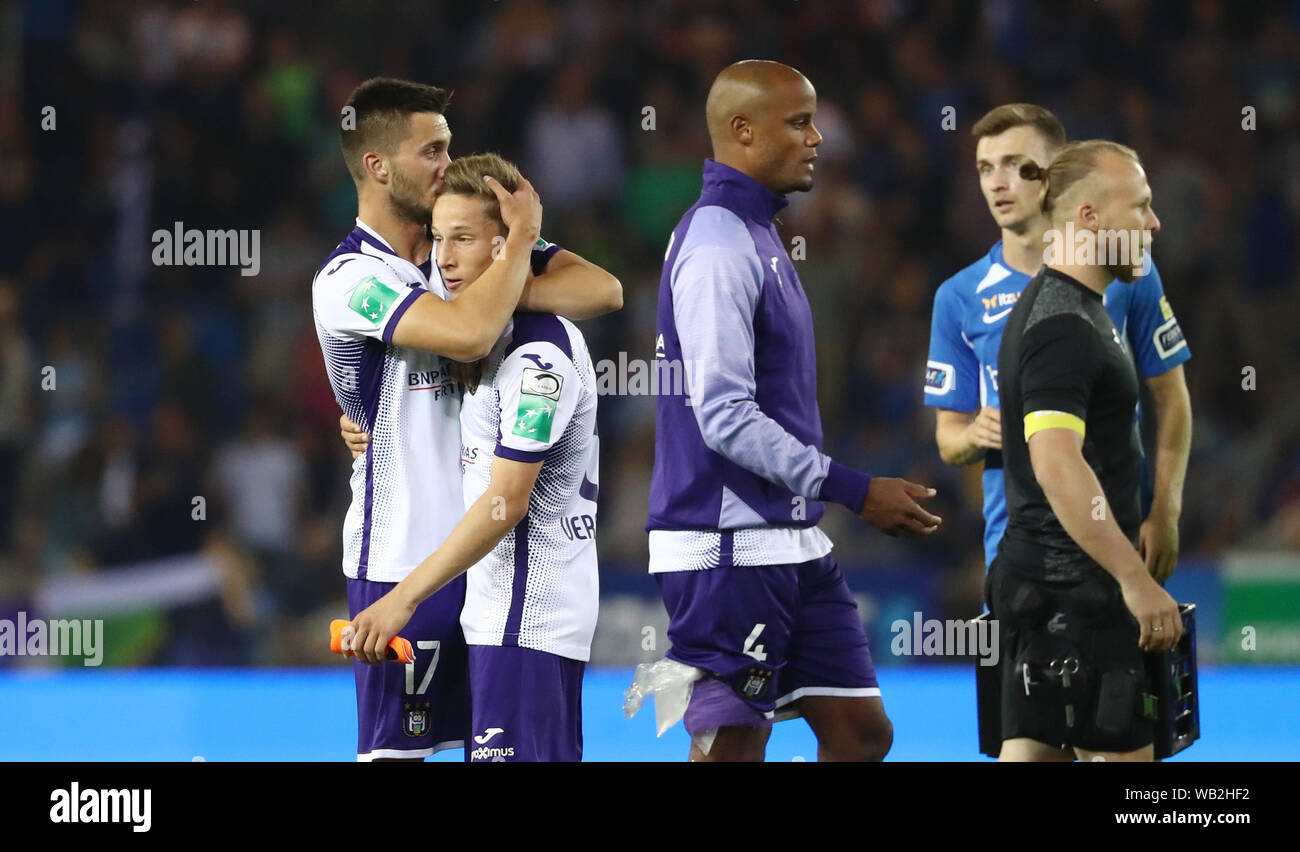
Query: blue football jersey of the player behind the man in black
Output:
[[926, 241, 1192, 565]]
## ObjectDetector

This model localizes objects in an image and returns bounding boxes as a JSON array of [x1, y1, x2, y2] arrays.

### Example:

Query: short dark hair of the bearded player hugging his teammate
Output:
[[338, 77, 451, 185]]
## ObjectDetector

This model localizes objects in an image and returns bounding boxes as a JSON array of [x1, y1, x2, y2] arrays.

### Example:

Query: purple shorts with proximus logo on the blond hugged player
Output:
[[468, 645, 586, 762]]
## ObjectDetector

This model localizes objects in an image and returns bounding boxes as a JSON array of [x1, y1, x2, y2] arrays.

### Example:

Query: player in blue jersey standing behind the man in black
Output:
[[926, 104, 1192, 583]]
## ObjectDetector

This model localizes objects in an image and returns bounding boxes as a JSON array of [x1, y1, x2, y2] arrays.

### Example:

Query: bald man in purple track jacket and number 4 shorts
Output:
[[633, 61, 940, 761]]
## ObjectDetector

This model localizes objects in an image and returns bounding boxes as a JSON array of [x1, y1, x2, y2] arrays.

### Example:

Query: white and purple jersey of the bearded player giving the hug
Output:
[[312, 219, 464, 583]]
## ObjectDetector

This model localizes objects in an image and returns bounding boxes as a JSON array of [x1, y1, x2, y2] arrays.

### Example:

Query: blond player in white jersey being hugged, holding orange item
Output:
[[352, 155, 598, 761]]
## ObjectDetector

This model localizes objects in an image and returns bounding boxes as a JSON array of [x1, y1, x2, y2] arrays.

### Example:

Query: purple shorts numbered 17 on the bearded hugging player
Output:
[[347, 575, 469, 761]]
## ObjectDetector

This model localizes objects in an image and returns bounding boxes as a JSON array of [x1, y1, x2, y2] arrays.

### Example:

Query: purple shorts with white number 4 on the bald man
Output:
[[655, 555, 880, 734]]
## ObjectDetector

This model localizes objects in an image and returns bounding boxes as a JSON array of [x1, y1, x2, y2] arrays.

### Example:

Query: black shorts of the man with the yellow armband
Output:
[[985, 555, 1154, 752]]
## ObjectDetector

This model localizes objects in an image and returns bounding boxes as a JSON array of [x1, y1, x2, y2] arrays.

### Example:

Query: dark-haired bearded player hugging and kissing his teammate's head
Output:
[[312, 78, 621, 760]]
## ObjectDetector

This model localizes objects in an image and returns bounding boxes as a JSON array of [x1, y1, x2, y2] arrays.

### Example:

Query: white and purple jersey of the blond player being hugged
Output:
[[460, 312, 599, 662]]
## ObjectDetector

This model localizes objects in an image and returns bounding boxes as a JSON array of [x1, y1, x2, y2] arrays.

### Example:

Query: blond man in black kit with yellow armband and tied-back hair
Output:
[[988, 139, 1183, 761]]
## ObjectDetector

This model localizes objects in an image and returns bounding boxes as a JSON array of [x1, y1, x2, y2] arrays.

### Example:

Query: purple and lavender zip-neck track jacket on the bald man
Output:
[[646, 160, 870, 574]]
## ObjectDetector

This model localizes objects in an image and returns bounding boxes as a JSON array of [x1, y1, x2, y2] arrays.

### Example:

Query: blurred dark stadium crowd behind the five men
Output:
[[0, 0, 1300, 665]]
